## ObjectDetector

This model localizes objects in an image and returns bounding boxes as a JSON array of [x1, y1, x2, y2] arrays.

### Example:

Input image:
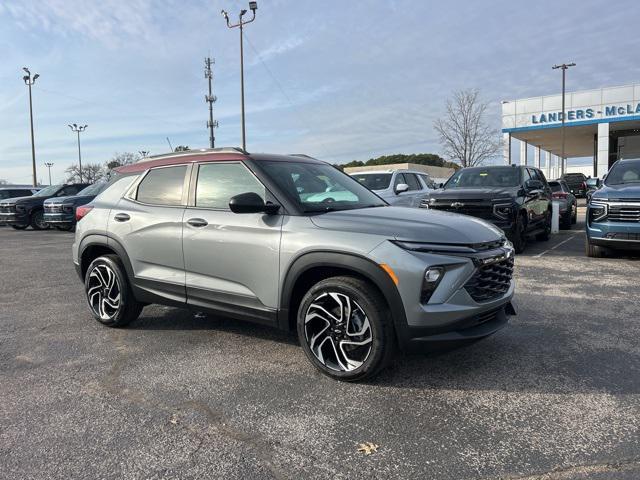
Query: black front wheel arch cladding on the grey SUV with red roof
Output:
[[278, 251, 407, 332]]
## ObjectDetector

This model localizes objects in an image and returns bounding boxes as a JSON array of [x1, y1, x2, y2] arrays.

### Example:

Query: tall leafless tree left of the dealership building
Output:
[[433, 89, 502, 167]]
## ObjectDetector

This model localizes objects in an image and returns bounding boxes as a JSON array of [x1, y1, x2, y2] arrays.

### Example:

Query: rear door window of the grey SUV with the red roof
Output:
[[136, 165, 187, 205]]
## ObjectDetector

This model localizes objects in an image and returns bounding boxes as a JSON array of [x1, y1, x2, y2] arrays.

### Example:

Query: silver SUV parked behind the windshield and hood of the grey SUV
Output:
[[350, 170, 436, 208]]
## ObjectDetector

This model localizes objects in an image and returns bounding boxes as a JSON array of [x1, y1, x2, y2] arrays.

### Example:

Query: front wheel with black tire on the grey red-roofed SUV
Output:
[[297, 276, 395, 381]]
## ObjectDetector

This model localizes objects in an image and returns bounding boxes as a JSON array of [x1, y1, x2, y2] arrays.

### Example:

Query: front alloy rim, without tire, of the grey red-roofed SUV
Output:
[[304, 292, 373, 372]]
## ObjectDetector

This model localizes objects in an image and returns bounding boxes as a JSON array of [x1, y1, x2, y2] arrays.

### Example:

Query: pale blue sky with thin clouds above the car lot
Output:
[[0, 0, 640, 183]]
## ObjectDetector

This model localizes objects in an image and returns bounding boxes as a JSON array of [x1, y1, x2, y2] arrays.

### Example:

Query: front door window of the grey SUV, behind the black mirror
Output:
[[196, 163, 264, 209]]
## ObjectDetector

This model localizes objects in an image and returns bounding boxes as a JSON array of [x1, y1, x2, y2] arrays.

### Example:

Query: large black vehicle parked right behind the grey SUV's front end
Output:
[[420, 165, 551, 253]]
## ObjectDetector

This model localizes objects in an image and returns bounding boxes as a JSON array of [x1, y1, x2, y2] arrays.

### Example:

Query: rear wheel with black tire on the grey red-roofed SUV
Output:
[[84, 255, 143, 327]]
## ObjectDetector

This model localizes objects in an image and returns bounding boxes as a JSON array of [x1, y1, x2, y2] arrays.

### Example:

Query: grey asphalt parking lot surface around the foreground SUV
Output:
[[0, 215, 640, 479]]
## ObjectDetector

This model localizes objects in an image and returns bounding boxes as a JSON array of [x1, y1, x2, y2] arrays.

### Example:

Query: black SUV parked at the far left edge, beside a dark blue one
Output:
[[0, 183, 89, 230]]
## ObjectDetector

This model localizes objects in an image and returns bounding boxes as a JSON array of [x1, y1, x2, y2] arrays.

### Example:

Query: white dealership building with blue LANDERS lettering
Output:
[[502, 84, 640, 178]]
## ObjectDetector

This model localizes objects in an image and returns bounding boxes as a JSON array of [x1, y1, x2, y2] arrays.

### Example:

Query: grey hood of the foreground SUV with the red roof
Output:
[[311, 207, 504, 244]]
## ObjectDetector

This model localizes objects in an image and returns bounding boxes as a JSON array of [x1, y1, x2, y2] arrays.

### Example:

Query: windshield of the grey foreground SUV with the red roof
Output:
[[260, 161, 386, 213]]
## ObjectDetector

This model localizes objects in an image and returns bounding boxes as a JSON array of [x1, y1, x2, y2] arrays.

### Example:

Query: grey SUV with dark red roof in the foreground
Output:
[[73, 149, 515, 380]]
